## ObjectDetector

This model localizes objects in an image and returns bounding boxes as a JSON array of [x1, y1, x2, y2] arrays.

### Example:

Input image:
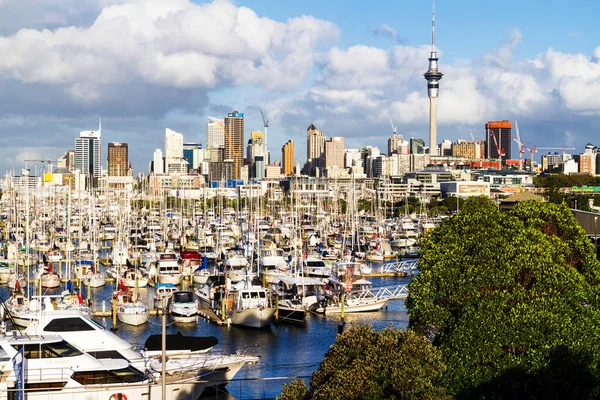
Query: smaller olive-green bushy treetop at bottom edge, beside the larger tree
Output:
[[279, 325, 447, 400]]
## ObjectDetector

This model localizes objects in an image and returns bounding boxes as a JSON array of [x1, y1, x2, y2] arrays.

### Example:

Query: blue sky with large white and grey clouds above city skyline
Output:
[[0, 0, 600, 174]]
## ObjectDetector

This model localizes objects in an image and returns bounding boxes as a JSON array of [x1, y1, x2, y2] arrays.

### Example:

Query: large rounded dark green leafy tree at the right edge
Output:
[[407, 197, 600, 398]]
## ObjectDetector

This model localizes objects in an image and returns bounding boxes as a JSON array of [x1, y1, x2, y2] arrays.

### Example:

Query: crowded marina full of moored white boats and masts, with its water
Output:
[[0, 170, 426, 399]]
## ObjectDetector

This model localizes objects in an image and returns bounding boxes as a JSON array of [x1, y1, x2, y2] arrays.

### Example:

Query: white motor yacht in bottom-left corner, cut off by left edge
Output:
[[0, 334, 152, 400]]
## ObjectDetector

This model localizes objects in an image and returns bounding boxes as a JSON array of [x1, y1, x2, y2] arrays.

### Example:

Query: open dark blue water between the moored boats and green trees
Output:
[[0, 264, 410, 399]]
